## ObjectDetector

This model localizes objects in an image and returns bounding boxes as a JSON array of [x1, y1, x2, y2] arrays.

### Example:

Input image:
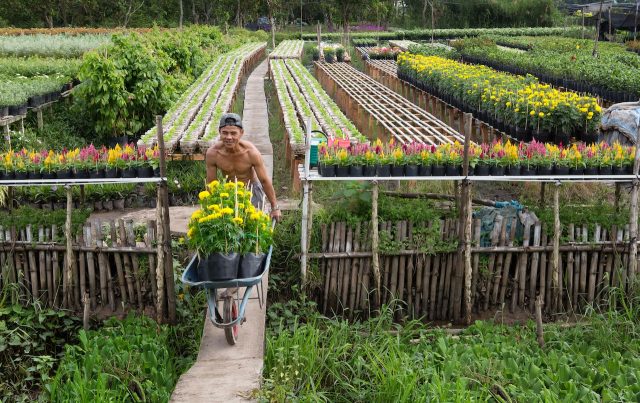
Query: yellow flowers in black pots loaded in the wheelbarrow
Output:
[[187, 180, 272, 281]]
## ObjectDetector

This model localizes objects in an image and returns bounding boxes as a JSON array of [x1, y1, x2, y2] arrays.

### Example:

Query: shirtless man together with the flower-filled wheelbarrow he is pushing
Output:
[[182, 114, 281, 344]]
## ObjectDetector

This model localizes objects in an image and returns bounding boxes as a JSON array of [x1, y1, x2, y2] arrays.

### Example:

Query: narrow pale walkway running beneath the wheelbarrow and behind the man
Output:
[[171, 60, 273, 403]]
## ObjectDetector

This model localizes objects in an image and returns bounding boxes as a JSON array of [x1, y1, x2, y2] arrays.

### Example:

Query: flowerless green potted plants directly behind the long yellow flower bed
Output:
[[454, 37, 640, 102]]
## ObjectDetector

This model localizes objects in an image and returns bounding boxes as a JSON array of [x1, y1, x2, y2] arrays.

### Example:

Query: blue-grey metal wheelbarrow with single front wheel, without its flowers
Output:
[[182, 246, 273, 345]]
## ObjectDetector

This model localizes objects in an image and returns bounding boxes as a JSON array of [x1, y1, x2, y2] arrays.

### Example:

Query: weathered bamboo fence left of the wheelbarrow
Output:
[[0, 219, 169, 313]]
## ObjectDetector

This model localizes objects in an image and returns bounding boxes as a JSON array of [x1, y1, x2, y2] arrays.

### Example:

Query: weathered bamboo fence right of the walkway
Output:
[[309, 216, 638, 321]]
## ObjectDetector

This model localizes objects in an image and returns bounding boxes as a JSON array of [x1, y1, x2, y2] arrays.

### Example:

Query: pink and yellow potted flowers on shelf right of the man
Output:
[[318, 140, 635, 177]]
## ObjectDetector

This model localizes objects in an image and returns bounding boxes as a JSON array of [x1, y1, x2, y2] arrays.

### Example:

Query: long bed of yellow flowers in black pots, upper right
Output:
[[398, 53, 602, 144]]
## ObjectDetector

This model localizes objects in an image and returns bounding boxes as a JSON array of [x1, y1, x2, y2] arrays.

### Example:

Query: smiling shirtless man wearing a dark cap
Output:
[[205, 113, 282, 221]]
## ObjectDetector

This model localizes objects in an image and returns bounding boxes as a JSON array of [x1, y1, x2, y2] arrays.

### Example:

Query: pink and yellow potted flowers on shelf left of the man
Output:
[[0, 144, 160, 180]]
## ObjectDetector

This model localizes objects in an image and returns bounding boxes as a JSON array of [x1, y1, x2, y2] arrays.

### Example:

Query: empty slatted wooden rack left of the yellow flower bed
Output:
[[315, 63, 464, 145]]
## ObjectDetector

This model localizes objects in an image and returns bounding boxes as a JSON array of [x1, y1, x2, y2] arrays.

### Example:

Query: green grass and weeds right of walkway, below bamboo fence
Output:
[[261, 286, 640, 402]]
